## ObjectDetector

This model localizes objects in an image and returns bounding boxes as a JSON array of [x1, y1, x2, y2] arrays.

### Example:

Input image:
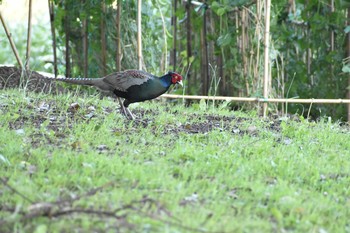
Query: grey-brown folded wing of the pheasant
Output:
[[103, 70, 154, 92]]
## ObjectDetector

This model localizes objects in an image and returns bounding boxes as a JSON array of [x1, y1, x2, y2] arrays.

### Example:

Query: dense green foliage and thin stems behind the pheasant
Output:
[[1, 0, 350, 119]]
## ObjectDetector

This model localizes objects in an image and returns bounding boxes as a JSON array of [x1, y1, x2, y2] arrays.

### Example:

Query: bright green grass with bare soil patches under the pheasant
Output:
[[0, 90, 350, 233]]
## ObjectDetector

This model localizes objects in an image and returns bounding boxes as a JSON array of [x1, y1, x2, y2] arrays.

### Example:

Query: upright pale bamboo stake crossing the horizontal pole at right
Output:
[[263, 0, 271, 117]]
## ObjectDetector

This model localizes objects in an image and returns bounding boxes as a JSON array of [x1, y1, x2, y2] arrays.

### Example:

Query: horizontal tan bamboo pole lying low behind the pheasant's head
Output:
[[161, 94, 350, 104]]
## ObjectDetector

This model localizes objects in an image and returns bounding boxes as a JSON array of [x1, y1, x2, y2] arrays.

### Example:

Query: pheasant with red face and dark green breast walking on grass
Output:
[[43, 70, 182, 120]]
